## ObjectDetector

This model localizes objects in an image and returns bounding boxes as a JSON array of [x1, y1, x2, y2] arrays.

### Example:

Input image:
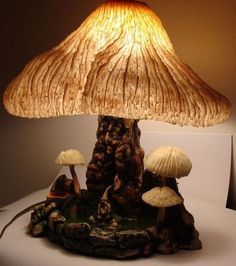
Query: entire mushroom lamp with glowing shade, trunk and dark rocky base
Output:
[[1, 0, 231, 259]]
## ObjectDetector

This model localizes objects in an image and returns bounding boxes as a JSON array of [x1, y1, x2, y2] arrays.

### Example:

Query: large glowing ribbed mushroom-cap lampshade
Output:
[[4, 0, 230, 127]]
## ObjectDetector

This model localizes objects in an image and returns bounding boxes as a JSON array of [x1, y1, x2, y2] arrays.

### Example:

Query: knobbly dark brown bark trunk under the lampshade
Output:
[[86, 116, 144, 205]]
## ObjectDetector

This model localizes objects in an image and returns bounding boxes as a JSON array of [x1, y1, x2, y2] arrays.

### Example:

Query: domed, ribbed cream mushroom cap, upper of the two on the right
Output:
[[144, 146, 192, 178]]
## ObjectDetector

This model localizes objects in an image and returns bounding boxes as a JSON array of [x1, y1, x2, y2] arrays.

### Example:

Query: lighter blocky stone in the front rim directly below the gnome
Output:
[[89, 228, 116, 247]]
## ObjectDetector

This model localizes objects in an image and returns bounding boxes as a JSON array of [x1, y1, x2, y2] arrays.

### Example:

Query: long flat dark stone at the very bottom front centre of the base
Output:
[[95, 247, 139, 260]]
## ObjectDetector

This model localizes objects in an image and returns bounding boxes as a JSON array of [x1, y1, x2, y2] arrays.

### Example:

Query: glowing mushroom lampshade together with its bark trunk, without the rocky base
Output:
[[1, 0, 231, 258]]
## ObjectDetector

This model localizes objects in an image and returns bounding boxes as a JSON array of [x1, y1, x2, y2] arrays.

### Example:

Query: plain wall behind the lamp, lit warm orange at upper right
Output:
[[0, 0, 236, 208]]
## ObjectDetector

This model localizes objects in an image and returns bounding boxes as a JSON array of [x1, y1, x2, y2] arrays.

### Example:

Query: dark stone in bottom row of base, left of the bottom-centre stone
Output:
[[61, 236, 93, 254]]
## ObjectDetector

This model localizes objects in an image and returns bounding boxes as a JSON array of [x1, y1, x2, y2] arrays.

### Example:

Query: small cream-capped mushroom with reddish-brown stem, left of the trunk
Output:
[[55, 149, 85, 197]]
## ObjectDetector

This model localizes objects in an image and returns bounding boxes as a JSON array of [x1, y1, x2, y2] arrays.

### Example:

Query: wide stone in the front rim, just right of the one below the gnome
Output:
[[117, 230, 151, 249]]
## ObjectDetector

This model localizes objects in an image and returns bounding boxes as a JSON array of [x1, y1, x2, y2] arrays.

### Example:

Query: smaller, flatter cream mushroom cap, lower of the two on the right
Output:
[[142, 187, 183, 208]]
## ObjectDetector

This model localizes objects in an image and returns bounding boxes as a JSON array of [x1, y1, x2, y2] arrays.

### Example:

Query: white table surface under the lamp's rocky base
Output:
[[0, 188, 236, 266]]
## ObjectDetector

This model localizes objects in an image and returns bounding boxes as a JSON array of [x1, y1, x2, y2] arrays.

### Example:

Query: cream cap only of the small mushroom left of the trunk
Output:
[[55, 149, 85, 165]]
